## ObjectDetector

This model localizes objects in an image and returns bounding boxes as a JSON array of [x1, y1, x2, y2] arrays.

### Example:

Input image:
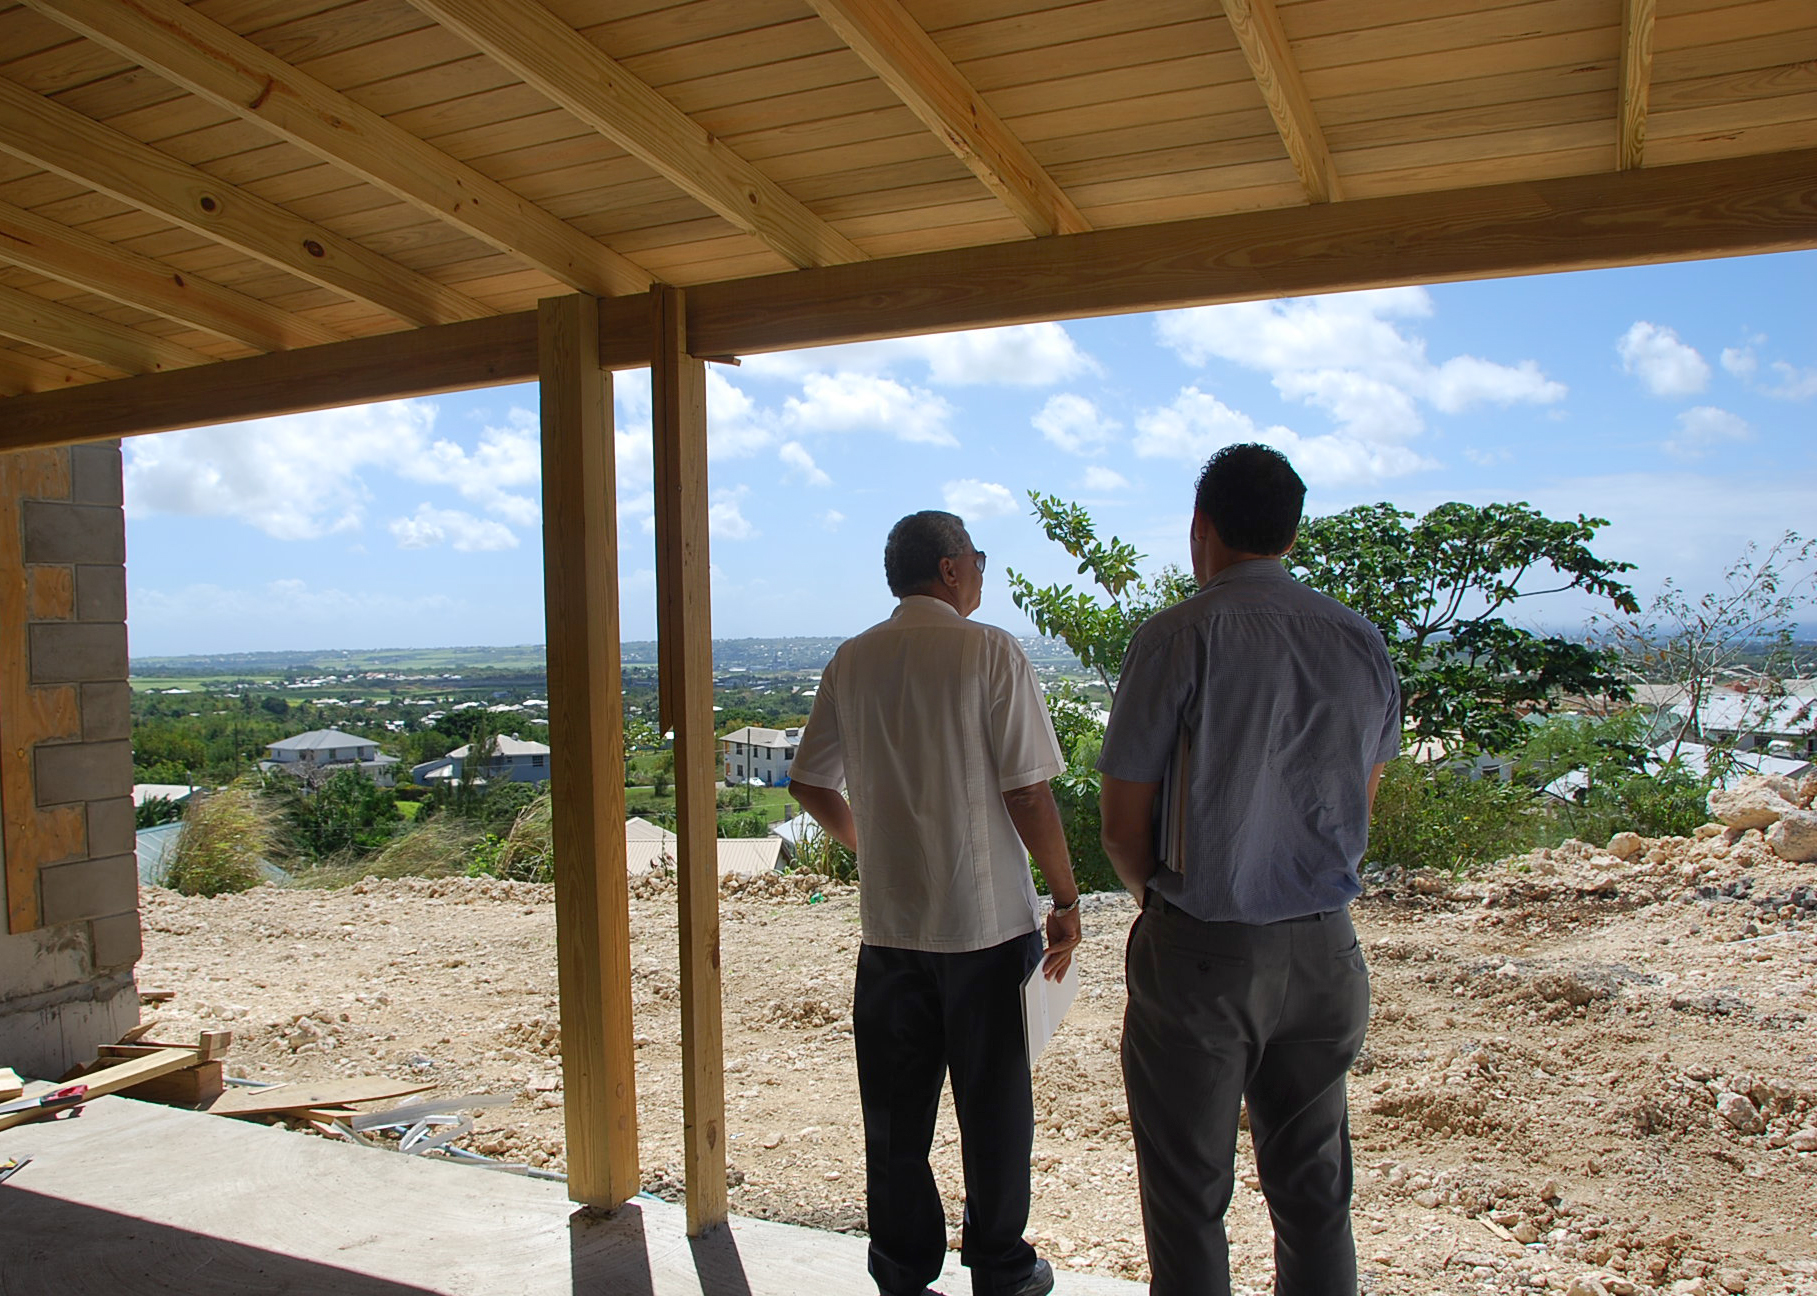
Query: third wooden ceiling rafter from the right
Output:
[[809, 0, 1092, 236]]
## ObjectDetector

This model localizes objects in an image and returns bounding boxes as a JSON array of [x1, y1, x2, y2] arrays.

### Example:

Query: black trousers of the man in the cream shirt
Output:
[[852, 932, 1041, 1296]]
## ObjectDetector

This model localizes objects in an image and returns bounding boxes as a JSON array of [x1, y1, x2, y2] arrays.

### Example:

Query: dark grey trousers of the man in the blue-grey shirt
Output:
[[1123, 894, 1368, 1296]]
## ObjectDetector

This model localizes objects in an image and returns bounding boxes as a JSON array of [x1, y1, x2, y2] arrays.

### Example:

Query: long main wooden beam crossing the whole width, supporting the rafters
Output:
[[0, 149, 1817, 449]]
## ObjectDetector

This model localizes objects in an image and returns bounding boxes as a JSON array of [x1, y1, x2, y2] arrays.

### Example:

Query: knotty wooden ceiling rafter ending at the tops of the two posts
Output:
[[27, 0, 650, 294]]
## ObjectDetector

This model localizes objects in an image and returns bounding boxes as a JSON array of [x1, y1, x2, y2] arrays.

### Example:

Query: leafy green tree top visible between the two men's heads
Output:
[[1008, 491, 1197, 696]]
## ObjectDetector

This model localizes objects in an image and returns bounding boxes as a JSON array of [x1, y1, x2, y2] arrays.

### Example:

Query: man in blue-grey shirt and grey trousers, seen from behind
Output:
[[1097, 445, 1401, 1296]]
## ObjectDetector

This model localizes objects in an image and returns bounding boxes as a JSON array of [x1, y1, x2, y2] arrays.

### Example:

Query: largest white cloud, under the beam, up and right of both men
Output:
[[1156, 287, 1564, 442]]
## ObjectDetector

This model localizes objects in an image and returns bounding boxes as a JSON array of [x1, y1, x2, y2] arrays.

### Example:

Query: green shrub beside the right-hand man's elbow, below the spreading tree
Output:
[[1365, 760, 1543, 878]]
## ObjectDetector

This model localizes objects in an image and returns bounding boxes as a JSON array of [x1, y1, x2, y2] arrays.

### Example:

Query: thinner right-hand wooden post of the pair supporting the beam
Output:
[[650, 284, 727, 1238]]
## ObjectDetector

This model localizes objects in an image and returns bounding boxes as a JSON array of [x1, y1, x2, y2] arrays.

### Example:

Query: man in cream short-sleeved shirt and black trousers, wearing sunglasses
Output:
[[790, 511, 1079, 1296]]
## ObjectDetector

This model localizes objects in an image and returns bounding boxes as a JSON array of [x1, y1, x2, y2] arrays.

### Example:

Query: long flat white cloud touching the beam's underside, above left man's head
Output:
[[743, 324, 1099, 387]]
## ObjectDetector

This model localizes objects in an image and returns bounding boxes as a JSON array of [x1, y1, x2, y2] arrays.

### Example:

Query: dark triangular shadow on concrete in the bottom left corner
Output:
[[0, 1183, 446, 1296]]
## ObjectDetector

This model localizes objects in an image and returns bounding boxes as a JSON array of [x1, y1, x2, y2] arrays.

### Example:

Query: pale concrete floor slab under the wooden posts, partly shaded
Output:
[[0, 1098, 1143, 1296]]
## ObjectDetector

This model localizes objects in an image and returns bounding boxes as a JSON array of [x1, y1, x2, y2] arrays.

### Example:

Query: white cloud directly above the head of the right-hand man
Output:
[[1136, 387, 1435, 487]]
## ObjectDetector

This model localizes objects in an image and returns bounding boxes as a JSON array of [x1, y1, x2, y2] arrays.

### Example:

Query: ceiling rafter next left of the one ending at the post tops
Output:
[[0, 78, 492, 324]]
